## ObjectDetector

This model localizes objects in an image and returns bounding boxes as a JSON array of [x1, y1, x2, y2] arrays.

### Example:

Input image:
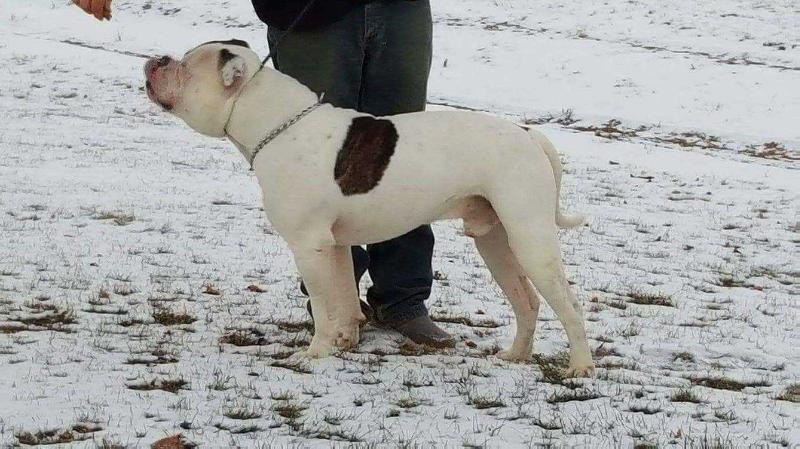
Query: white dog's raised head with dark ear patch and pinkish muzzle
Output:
[[144, 39, 261, 137]]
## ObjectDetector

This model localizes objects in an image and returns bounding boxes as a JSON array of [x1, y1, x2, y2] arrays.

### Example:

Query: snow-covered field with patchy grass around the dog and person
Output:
[[0, 0, 800, 449]]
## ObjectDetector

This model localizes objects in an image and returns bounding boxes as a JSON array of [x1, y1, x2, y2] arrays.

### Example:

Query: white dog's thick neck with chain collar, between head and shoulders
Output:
[[225, 67, 318, 164]]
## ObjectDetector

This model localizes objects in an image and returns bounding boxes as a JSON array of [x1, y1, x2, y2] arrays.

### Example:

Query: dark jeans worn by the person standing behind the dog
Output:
[[269, 0, 434, 320]]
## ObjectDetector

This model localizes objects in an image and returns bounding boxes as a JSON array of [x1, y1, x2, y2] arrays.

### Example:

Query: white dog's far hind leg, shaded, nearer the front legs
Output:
[[475, 223, 540, 361]]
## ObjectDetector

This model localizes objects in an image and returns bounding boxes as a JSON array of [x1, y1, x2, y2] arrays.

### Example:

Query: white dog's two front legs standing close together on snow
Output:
[[292, 242, 366, 358]]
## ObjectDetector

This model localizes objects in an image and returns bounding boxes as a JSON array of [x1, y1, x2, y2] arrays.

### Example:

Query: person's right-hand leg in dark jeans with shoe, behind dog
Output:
[[358, 0, 453, 346]]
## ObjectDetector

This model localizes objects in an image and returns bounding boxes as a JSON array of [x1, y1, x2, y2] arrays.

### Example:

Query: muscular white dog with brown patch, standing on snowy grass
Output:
[[145, 40, 594, 376]]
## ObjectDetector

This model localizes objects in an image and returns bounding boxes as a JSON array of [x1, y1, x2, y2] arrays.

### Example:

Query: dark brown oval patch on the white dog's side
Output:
[[333, 116, 398, 196]]
